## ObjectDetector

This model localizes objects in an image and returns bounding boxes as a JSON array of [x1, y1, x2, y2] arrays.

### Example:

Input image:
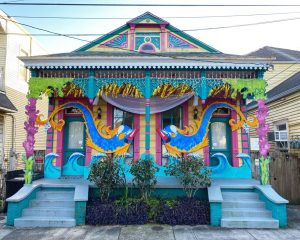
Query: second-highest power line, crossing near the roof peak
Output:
[[9, 12, 300, 20]]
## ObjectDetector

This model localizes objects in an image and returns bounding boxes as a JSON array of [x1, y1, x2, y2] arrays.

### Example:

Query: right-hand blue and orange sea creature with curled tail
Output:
[[157, 102, 258, 156]]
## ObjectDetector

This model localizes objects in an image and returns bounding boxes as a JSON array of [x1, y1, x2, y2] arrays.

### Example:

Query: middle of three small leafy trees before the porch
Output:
[[130, 158, 158, 201]]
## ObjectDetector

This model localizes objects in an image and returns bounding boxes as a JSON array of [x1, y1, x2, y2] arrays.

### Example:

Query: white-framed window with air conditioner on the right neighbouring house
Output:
[[274, 121, 289, 149]]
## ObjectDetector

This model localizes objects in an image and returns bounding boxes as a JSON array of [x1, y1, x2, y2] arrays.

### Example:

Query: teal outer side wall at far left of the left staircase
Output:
[[6, 188, 41, 226]]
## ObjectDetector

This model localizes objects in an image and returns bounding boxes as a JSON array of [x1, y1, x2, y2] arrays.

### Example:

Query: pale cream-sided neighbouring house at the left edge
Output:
[[0, 10, 48, 169]]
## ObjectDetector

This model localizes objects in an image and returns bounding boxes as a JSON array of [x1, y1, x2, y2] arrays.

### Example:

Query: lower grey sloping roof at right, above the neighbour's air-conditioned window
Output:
[[247, 72, 300, 110]]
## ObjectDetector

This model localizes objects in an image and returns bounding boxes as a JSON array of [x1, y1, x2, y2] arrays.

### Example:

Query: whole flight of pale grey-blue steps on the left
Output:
[[14, 190, 76, 228]]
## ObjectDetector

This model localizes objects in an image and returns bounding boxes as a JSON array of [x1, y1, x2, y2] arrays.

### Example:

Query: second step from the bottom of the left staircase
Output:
[[22, 207, 75, 218]]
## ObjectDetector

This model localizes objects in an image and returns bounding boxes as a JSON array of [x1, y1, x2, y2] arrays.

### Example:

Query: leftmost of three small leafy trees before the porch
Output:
[[88, 156, 122, 201]]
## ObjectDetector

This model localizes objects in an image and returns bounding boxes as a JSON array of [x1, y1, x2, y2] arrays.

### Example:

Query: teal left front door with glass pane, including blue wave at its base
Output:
[[62, 117, 86, 176]]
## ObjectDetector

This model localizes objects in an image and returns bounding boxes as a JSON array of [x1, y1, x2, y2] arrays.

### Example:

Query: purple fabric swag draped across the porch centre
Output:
[[102, 93, 193, 114]]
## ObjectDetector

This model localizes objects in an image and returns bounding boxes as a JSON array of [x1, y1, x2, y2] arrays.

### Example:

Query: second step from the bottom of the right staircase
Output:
[[222, 208, 272, 218]]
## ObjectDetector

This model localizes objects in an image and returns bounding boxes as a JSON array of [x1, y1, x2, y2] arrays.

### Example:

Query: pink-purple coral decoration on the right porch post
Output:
[[256, 99, 270, 158]]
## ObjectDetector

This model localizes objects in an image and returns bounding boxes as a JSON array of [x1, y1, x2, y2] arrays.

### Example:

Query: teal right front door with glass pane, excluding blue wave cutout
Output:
[[209, 117, 232, 166]]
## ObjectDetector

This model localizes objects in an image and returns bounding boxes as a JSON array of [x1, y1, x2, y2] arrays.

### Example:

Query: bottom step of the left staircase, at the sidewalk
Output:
[[14, 216, 76, 228]]
